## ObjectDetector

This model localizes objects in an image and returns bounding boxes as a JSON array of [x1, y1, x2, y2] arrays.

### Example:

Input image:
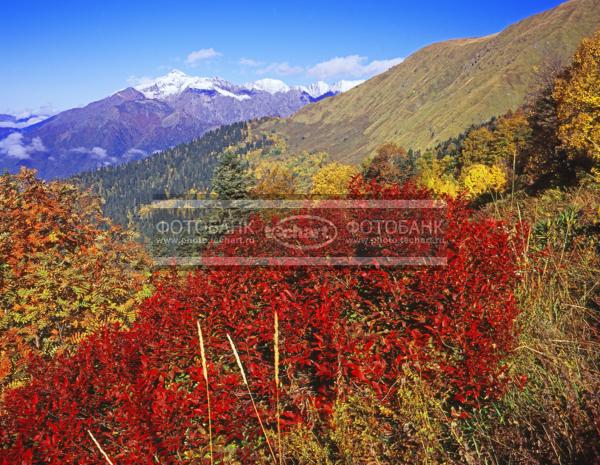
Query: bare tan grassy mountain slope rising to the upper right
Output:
[[261, 0, 600, 161]]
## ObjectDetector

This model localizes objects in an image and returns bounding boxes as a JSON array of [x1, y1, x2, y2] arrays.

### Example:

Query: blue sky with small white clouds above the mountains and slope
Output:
[[0, 0, 561, 112]]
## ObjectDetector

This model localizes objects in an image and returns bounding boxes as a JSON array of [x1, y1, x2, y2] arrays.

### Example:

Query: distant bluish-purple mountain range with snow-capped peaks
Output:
[[0, 70, 362, 178]]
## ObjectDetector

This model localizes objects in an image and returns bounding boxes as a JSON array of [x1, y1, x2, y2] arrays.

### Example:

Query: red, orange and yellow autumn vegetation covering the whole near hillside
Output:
[[0, 11, 600, 465]]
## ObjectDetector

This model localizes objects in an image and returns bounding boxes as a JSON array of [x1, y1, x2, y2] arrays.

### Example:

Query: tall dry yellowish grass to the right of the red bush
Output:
[[465, 186, 600, 464]]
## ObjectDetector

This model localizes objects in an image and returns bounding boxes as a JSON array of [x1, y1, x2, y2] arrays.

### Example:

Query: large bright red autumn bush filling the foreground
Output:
[[0, 180, 520, 465]]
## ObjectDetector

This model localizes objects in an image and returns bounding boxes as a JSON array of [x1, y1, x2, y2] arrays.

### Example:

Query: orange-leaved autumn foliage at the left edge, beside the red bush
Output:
[[0, 169, 148, 390]]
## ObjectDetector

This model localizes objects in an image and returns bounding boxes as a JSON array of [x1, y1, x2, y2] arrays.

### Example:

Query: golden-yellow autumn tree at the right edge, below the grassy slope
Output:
[[553, 30, 600, 163]]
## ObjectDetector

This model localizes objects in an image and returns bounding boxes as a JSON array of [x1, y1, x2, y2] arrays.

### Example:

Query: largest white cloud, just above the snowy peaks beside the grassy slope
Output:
[[307, 55, 404, 79]]
